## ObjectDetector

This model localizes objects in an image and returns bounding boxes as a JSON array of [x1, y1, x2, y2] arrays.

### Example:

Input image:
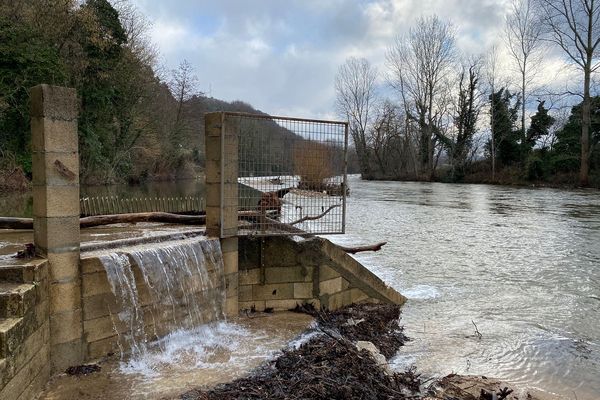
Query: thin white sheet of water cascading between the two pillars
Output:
[[99, 238, 225, 359]]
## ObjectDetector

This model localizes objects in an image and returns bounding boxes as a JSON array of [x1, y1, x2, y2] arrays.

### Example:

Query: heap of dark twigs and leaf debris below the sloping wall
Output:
[[180, 304, 420, 400]]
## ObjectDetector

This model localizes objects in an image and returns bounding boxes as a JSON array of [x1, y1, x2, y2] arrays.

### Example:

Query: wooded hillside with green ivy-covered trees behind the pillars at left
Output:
[[0, 0, 304, 190]]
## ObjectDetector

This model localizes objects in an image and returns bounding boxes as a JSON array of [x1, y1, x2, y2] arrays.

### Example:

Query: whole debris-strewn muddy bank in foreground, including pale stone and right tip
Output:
[[178, 304, 564, 400]]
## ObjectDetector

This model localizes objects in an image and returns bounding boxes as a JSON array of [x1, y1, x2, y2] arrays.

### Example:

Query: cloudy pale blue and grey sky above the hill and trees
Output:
[[134, 0, 556, 118]]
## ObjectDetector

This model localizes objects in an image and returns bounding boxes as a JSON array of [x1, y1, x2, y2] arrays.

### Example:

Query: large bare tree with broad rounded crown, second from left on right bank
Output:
[[387, 16, 456, 179]]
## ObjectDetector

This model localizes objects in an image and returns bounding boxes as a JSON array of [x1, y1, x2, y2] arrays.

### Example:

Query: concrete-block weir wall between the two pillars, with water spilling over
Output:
[[80, 236, 226, 359]]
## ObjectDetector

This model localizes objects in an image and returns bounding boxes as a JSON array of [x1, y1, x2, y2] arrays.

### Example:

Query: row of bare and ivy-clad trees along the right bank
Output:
[[335, 7, 600, 187]]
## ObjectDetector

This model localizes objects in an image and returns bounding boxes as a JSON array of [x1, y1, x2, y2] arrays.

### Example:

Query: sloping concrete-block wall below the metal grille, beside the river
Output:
[[238, 237, 406, 311]]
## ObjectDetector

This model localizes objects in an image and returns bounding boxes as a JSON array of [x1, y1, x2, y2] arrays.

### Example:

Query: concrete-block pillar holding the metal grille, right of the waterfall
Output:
[[204, 112, 238, 316]]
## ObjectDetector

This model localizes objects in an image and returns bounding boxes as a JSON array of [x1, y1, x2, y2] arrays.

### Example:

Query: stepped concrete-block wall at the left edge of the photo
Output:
[[0, 259, 51, 400]]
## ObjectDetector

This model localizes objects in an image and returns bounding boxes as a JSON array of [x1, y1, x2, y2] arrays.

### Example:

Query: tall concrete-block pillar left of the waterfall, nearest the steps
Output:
[[30, 85, 83, 372]]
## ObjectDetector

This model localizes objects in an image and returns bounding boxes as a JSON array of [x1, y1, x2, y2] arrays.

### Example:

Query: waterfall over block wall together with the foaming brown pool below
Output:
[[41, 235, 312, 399]]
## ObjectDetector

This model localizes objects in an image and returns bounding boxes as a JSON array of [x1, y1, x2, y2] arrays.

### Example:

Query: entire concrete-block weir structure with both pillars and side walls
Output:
[[0, 85, 405, 400]]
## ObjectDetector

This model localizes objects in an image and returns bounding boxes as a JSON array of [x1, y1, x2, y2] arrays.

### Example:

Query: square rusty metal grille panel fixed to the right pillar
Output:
[[223, 113, 348, 236]]
